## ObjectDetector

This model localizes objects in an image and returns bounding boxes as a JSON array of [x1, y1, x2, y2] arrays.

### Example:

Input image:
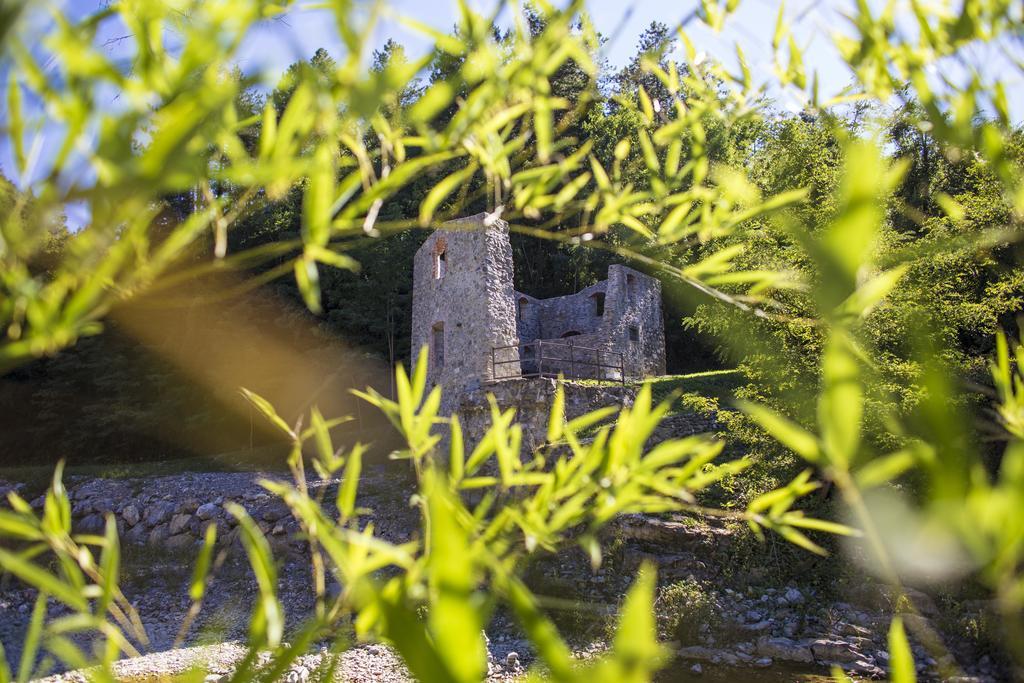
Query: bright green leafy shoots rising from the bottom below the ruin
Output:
[[0, 354, 840, 683]]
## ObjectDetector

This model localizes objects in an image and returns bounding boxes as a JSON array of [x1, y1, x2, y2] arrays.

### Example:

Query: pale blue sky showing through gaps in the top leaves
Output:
[[0, 0, 1024, 225]]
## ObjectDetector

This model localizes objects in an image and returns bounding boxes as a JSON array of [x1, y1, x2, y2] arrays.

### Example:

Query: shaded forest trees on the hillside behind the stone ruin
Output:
[[0, 11, 1024, 471]]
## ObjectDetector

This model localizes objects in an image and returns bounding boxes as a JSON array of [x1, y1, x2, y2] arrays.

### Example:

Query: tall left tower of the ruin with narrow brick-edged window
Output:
[[412, 213, 519, 405]]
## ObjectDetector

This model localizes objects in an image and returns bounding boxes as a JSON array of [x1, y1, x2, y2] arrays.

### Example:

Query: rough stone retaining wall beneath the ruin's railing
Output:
[[456, 377, 636, 454]]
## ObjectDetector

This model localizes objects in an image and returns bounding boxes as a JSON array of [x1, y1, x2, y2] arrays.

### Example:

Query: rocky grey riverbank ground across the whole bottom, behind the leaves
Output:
[[0, 468, 999, 683]]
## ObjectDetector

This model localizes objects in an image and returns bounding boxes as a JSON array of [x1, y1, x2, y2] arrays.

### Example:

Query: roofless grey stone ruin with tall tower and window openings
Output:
[[412, 213, 665, 414]]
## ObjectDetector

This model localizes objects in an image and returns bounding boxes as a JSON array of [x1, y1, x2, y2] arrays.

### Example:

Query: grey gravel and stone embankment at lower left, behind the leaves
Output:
[[0, 472, 544, 683]]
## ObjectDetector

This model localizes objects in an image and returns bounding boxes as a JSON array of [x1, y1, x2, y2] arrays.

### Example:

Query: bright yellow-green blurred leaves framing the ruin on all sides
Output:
[[0, 0, 1024, 682]]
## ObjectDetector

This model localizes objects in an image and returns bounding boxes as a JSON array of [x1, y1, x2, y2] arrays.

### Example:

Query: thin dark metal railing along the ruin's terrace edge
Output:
[[490, 338, 626, 386]]
